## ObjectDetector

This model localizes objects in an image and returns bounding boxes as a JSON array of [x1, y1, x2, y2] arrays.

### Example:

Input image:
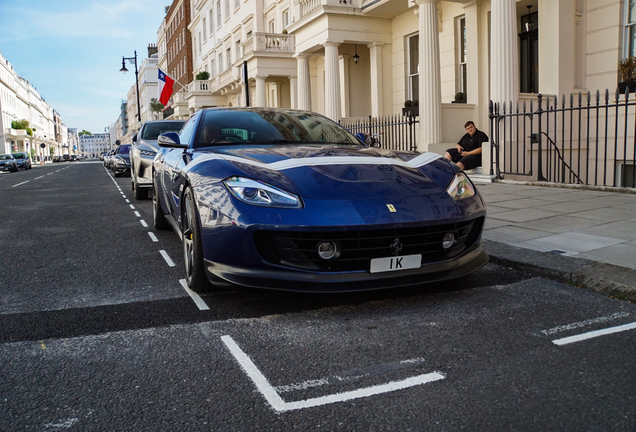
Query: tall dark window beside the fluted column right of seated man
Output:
[[519, 8, 539, 93]]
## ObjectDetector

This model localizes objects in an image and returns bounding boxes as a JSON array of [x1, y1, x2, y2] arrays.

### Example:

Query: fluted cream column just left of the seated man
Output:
[[415, 0, 440, 151]]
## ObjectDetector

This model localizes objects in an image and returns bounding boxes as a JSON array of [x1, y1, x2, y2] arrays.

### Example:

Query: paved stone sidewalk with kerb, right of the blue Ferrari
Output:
[[477, 182, 636, 301]]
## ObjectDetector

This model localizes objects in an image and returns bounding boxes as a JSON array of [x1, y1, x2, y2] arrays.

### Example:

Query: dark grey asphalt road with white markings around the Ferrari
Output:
[[0, 162, 636, 431]]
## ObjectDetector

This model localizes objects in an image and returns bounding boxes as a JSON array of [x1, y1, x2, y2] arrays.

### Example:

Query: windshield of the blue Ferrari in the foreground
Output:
[[194, 109, 361, 148]]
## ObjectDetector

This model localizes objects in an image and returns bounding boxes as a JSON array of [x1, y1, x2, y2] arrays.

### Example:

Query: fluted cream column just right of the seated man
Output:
[[490, 0, 519, 107]]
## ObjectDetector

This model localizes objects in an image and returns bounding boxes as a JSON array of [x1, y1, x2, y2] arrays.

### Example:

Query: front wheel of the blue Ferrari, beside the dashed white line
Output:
[[182, 187, 212, 292]]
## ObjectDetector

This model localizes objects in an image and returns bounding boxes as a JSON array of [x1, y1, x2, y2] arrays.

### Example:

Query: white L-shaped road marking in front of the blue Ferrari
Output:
[[221, 335, 446, 412]]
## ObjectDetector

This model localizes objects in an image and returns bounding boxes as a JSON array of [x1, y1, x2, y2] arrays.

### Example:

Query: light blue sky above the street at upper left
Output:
[[0, 0, 171, 133]]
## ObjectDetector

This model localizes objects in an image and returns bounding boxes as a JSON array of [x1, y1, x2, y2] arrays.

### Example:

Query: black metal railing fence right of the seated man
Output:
[[489, 90, 636, 188]]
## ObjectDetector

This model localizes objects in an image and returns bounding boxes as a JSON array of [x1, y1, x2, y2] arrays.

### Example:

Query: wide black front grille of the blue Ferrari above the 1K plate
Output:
[[254, 217, 484, 272]]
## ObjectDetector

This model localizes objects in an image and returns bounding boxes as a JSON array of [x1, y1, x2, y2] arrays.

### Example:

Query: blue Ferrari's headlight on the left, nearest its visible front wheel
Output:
[[223, 177, 303, 208]]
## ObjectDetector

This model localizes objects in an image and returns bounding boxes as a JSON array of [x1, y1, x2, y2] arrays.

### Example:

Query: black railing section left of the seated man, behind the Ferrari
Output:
[[340, 114, 419, 151]]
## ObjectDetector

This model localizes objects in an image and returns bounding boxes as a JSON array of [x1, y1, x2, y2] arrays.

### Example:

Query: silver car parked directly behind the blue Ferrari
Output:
[[130, 120, 185, 199]]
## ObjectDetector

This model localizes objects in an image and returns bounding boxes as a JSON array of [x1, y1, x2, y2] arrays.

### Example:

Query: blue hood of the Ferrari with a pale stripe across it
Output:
[[193, 145, 455, 200]]
